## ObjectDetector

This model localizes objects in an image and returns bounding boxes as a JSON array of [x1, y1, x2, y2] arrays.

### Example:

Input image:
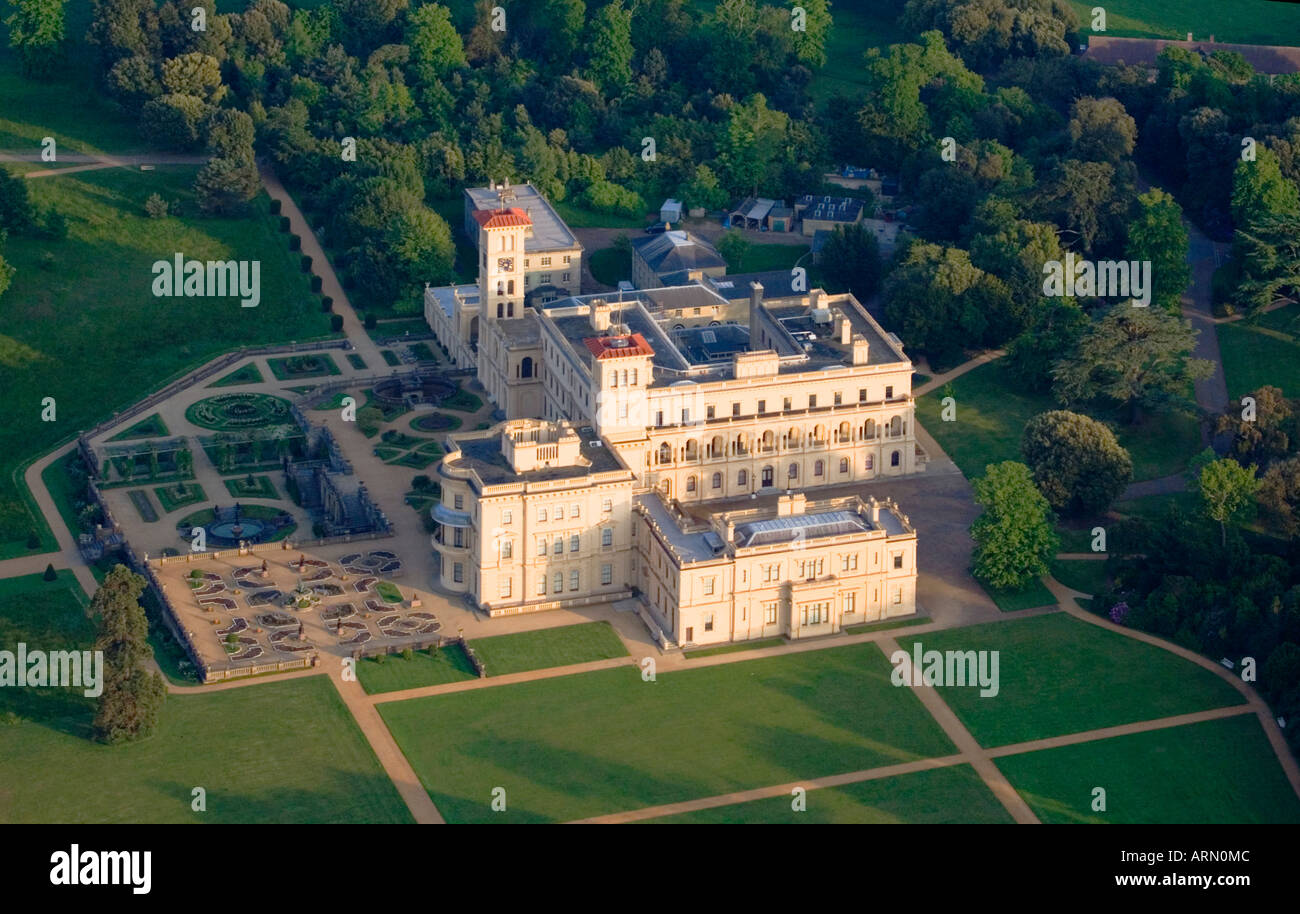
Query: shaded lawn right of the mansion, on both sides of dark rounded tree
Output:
[[917, 361, 1200, 481]]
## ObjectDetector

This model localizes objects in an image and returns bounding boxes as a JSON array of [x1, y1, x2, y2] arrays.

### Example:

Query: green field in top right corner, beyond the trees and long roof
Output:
[[1070, 0, 1300, 44]]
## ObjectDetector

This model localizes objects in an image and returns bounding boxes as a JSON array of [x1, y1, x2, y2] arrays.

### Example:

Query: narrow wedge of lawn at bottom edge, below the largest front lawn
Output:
[[646, 764, 1013, 826]]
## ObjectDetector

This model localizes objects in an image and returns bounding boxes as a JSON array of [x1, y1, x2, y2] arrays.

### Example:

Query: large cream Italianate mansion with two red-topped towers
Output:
[[425, 186, 924, 645]]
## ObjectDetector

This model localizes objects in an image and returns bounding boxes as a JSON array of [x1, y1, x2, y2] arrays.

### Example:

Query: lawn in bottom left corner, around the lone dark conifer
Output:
[[0, 572, 410, 823]]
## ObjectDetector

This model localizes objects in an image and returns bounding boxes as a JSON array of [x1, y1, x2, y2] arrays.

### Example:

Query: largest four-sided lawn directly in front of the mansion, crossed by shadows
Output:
[[378, 644, 954, 822]]
